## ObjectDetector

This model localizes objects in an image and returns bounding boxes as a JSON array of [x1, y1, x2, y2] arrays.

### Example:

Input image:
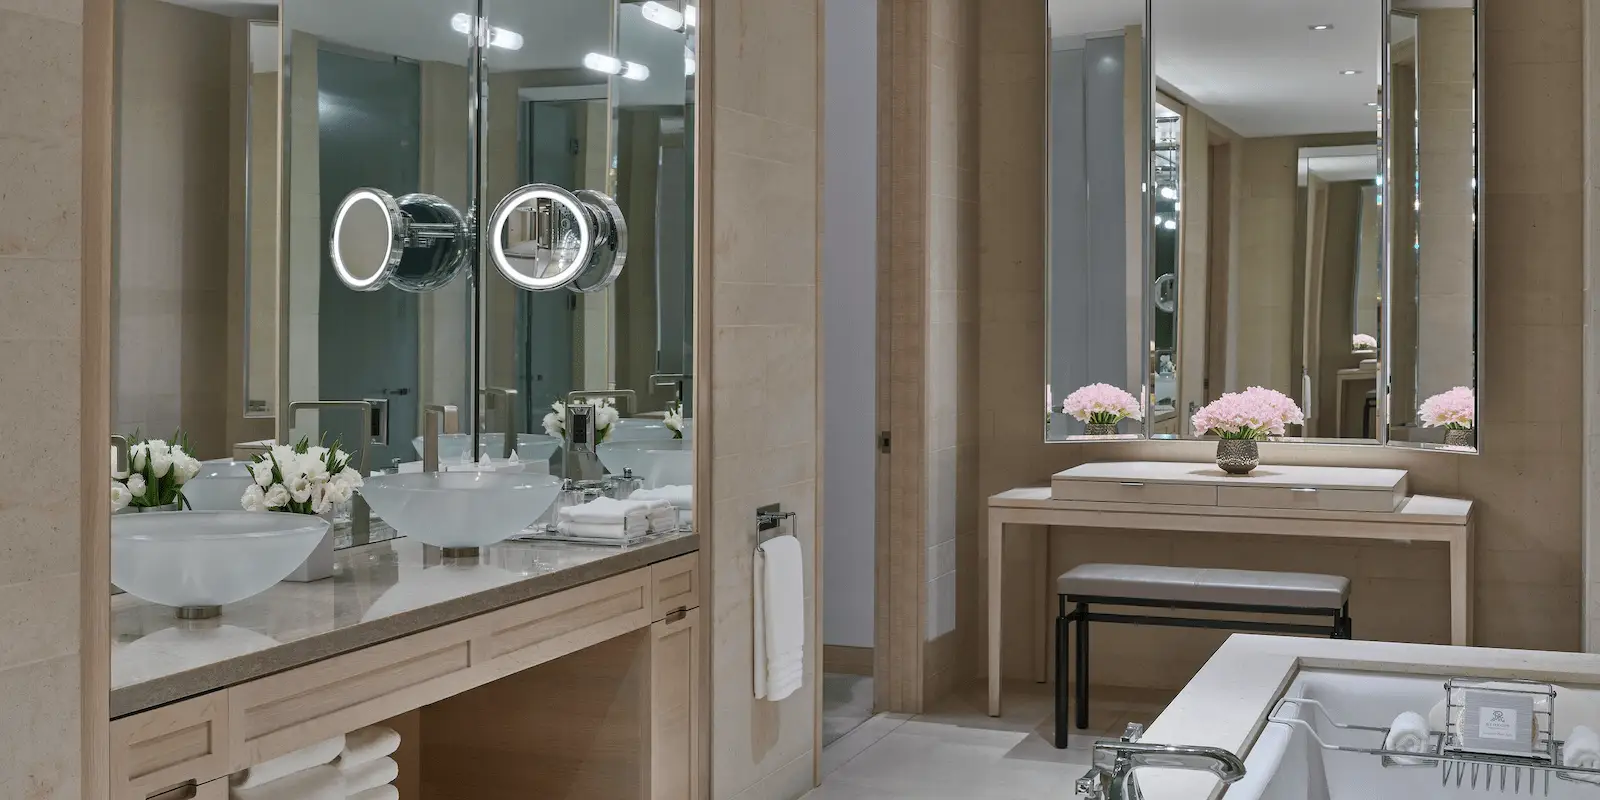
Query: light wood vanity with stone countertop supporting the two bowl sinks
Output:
[[110, 534, 704, 800]]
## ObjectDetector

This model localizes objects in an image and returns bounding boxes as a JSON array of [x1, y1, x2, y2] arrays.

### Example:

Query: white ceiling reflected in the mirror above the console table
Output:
[[1050, 0, 1414, 138]]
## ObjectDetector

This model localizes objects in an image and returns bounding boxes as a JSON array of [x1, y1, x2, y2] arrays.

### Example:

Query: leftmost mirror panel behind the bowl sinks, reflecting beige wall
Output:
[[110, 0, 282, 512]]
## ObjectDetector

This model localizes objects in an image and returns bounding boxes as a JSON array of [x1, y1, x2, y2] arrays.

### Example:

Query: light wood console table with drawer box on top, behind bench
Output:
[[986, 462, 1472, 717]]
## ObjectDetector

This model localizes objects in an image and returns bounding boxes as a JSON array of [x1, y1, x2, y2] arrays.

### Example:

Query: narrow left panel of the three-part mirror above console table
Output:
[[1045, 0, 1145, 440]]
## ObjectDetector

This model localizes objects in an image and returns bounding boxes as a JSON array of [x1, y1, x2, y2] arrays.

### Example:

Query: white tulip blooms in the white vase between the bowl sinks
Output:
[[238, 438, 363, 514]]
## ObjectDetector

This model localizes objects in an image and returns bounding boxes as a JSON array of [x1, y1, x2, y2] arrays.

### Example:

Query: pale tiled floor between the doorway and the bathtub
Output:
[[806, 683, 1170, 800]]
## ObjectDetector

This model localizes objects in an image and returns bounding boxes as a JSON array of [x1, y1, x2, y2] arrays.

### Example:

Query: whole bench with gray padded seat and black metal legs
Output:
[[1056, 563, 1352, 747]]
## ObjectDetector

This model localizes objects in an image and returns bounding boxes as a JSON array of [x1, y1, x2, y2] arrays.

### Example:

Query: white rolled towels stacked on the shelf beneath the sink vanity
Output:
[[229, 725, 400, 800]]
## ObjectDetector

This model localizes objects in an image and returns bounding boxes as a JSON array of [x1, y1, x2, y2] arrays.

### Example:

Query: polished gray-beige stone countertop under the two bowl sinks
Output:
[[110, 533, 699, 718]]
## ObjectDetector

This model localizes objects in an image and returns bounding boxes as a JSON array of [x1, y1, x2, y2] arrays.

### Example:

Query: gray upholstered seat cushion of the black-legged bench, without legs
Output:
[[1056, 563, 1350, 608]]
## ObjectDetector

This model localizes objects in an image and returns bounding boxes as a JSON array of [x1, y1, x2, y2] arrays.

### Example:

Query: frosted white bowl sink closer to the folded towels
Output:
[[357, 472, 562, 547]]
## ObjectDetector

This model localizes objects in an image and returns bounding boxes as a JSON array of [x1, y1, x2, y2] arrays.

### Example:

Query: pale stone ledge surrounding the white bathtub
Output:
[[1138, 634, 1600, 800]]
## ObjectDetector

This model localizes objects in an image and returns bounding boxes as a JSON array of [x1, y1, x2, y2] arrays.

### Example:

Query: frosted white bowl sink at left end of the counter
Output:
[[110, 510, 328, 611]]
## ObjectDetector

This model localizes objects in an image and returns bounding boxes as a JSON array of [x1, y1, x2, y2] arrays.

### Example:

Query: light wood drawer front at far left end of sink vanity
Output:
[[110, 691, 230, 800]]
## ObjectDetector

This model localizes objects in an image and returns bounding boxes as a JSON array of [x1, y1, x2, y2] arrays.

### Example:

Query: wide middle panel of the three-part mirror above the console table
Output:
[[1150, 0, 1382, 440]]
